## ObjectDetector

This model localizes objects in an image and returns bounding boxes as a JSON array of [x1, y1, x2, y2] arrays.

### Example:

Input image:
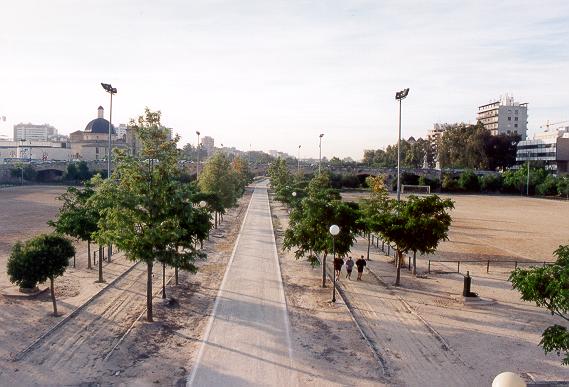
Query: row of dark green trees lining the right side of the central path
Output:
[[269, 160, 453, 286]]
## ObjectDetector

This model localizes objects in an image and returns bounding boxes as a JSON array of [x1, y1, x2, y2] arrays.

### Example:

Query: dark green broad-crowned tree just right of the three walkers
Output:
[[378, 195, 454, 286]]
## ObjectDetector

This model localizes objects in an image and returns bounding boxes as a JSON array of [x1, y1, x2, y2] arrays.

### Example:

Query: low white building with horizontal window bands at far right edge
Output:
[[516, 126, 569, 173]]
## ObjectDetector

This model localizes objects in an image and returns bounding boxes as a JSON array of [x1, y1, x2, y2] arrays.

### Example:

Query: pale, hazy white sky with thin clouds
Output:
[[0, 0, 569, 159]]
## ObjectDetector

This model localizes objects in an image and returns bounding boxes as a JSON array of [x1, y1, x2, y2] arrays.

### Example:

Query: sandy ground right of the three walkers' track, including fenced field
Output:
[[340, 192, 569, 385]]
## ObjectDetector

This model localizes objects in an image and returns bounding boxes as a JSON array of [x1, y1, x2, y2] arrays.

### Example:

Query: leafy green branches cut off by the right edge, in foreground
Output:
[[510, 246, 569, 365]]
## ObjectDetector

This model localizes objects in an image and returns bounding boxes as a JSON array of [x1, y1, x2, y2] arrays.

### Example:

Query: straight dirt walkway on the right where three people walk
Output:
[[329, 241, 480, 387]]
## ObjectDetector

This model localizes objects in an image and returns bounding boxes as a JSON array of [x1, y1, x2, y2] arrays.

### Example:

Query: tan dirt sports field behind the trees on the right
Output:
[[342, 193, 569, 266]]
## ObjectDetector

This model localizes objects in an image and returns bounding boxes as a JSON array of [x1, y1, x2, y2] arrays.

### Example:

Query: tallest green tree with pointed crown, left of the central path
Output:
[[91, 108, 200, 321]]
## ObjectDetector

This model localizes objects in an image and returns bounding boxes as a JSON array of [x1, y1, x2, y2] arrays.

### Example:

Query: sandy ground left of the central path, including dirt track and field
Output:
[[0, 187, 249, 385]]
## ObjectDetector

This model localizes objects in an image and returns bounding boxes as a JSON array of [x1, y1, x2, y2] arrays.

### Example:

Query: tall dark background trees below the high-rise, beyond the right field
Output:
[[363, 122, 521, 170]]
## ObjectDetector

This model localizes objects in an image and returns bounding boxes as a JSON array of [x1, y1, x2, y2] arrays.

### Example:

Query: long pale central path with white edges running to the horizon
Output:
[[188, 183, 298, 386]]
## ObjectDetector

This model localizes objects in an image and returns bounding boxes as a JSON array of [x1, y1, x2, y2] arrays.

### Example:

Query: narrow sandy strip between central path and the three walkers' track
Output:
[[271, 197, 386, 386]]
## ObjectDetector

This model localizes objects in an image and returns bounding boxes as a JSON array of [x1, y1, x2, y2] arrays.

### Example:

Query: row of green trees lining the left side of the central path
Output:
[[8, 109, 250, 321]]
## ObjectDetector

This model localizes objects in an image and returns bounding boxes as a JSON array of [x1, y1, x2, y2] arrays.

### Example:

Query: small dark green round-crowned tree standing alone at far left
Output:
[[7, 234, 75, 316]]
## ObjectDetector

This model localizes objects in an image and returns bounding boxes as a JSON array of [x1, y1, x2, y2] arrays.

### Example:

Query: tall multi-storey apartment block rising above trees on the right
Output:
[[476, 95, 528, 140]]
